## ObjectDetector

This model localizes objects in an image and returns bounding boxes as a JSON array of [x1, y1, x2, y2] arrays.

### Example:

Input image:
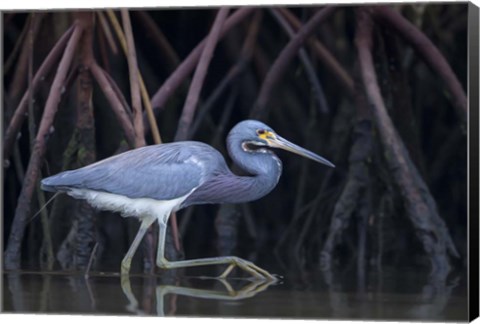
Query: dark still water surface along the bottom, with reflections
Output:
[[3, 270, 468, 321]]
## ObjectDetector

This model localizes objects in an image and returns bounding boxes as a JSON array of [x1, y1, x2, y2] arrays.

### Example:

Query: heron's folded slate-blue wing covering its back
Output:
[[42, 142, 223, 200]]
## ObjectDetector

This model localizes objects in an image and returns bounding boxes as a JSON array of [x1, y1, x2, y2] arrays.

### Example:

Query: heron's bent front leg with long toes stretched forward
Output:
[[157, 221, 277, 281]]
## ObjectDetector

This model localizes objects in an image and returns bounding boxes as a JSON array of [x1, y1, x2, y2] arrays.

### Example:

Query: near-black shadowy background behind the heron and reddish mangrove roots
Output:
[[3, 4, 468, 280]]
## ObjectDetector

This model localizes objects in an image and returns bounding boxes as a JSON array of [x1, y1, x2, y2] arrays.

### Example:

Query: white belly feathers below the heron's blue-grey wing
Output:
[[67, 188, 192, 222]]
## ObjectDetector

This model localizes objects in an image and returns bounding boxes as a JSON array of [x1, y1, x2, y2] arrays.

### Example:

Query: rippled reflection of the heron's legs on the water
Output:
[[120, 275, 278, 316]]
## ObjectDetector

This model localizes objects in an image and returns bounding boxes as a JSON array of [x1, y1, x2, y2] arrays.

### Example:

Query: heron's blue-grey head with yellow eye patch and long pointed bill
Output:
[[229, 120, 335, 167]]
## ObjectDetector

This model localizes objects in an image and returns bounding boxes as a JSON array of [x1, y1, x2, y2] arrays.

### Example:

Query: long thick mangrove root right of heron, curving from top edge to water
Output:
[[356, 9, 459, 277]]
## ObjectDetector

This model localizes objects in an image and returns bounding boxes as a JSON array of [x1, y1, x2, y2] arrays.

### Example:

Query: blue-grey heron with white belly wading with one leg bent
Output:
[[42, 120, 334, 280]]
